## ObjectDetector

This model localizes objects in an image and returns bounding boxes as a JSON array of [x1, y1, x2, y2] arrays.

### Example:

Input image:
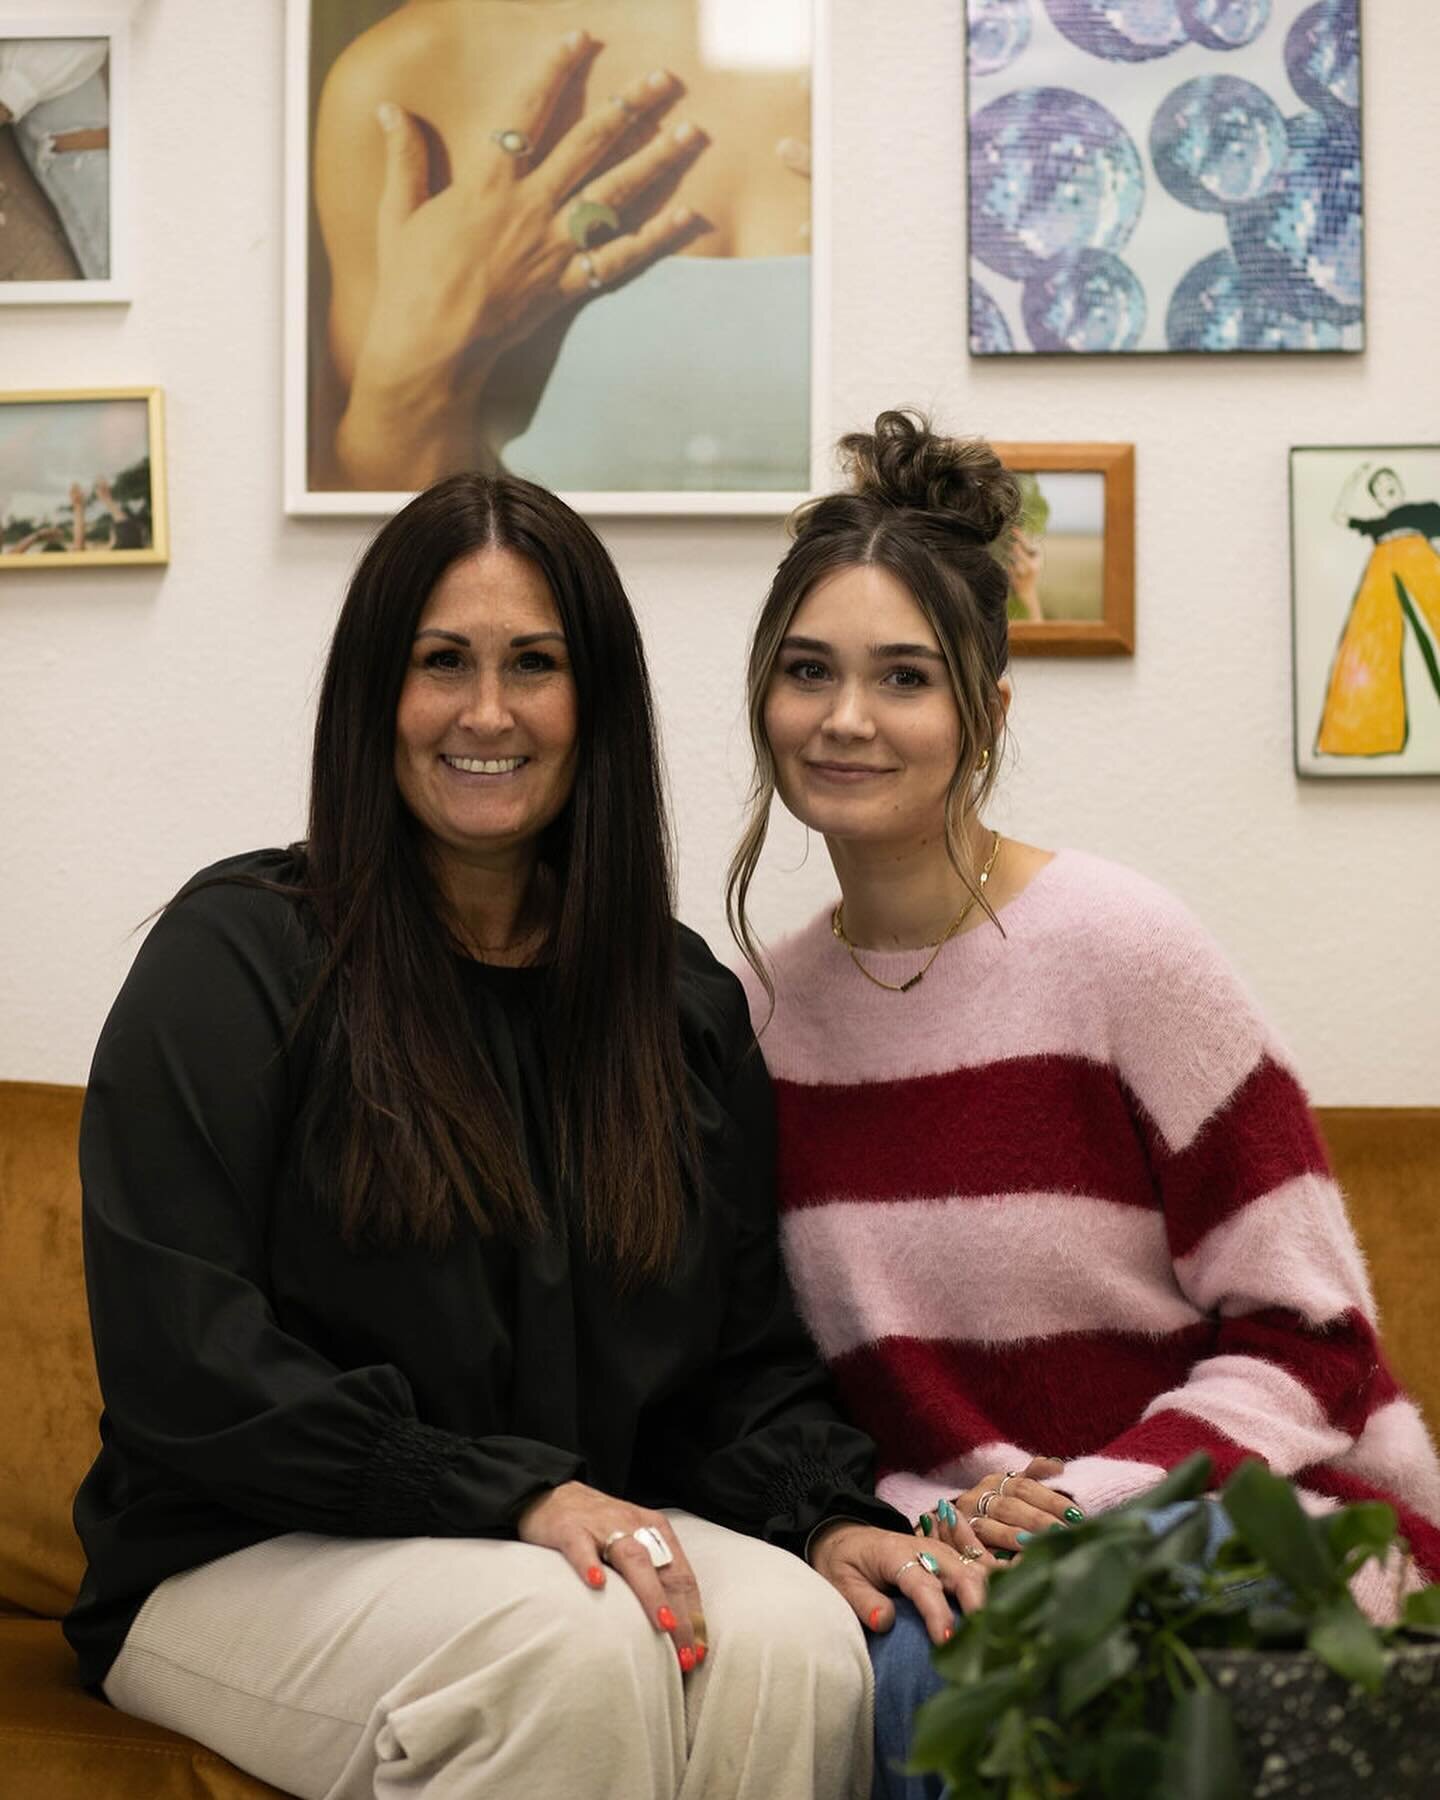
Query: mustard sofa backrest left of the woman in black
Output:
[[0, 1082, 101, 1620]]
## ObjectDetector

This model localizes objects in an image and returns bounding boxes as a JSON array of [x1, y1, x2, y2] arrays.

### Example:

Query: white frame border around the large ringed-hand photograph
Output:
[[284, 0, 833, 518]]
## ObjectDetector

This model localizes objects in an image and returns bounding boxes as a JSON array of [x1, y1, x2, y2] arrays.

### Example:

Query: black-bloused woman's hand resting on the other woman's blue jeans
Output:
[[810, 1519, 994, 1643]]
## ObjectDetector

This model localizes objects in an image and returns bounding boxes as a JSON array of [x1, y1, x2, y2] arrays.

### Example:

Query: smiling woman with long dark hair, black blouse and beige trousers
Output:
[[68, 475, 983, 1800]]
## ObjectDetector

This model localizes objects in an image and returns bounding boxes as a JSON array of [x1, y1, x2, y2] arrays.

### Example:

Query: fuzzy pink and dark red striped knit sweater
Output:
[[749, 851, 1440, 1611]]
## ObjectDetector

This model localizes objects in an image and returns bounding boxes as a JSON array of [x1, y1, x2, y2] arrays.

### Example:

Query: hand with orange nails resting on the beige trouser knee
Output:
[[515, 1481, 709, 1674]]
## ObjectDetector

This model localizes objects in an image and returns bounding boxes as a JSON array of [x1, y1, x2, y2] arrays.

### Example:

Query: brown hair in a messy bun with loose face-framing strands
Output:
[[725, 410, 1021, 1004]]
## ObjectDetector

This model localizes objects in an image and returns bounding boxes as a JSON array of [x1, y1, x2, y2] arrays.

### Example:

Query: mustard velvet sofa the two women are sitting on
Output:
[[0, 1082, 1440, 1800]]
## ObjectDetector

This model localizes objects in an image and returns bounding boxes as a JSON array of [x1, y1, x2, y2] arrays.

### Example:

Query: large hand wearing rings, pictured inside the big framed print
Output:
[[338, 32, 706, 488]]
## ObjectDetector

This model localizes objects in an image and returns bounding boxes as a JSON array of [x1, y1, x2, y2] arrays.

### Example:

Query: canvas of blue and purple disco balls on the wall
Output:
[[967, 0, 1364, 356]]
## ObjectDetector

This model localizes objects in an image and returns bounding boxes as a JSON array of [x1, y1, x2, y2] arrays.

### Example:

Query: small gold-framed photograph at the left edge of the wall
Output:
[[0, 387, 169, 574]]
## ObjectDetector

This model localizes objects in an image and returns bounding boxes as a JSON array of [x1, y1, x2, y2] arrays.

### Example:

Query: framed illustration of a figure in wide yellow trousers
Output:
[[1291, 445, 1440, 778]]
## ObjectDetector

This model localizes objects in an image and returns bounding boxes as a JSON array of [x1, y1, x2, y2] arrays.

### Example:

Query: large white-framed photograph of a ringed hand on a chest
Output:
[[284, 0, 832, 515]]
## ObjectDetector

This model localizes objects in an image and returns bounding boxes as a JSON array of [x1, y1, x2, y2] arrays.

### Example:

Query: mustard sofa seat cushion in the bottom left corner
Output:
[[0, 1618, 281, 1800]]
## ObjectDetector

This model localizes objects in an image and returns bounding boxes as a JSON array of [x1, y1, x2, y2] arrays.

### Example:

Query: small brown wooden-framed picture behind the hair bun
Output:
[[995, 445, 1136, 657]]
